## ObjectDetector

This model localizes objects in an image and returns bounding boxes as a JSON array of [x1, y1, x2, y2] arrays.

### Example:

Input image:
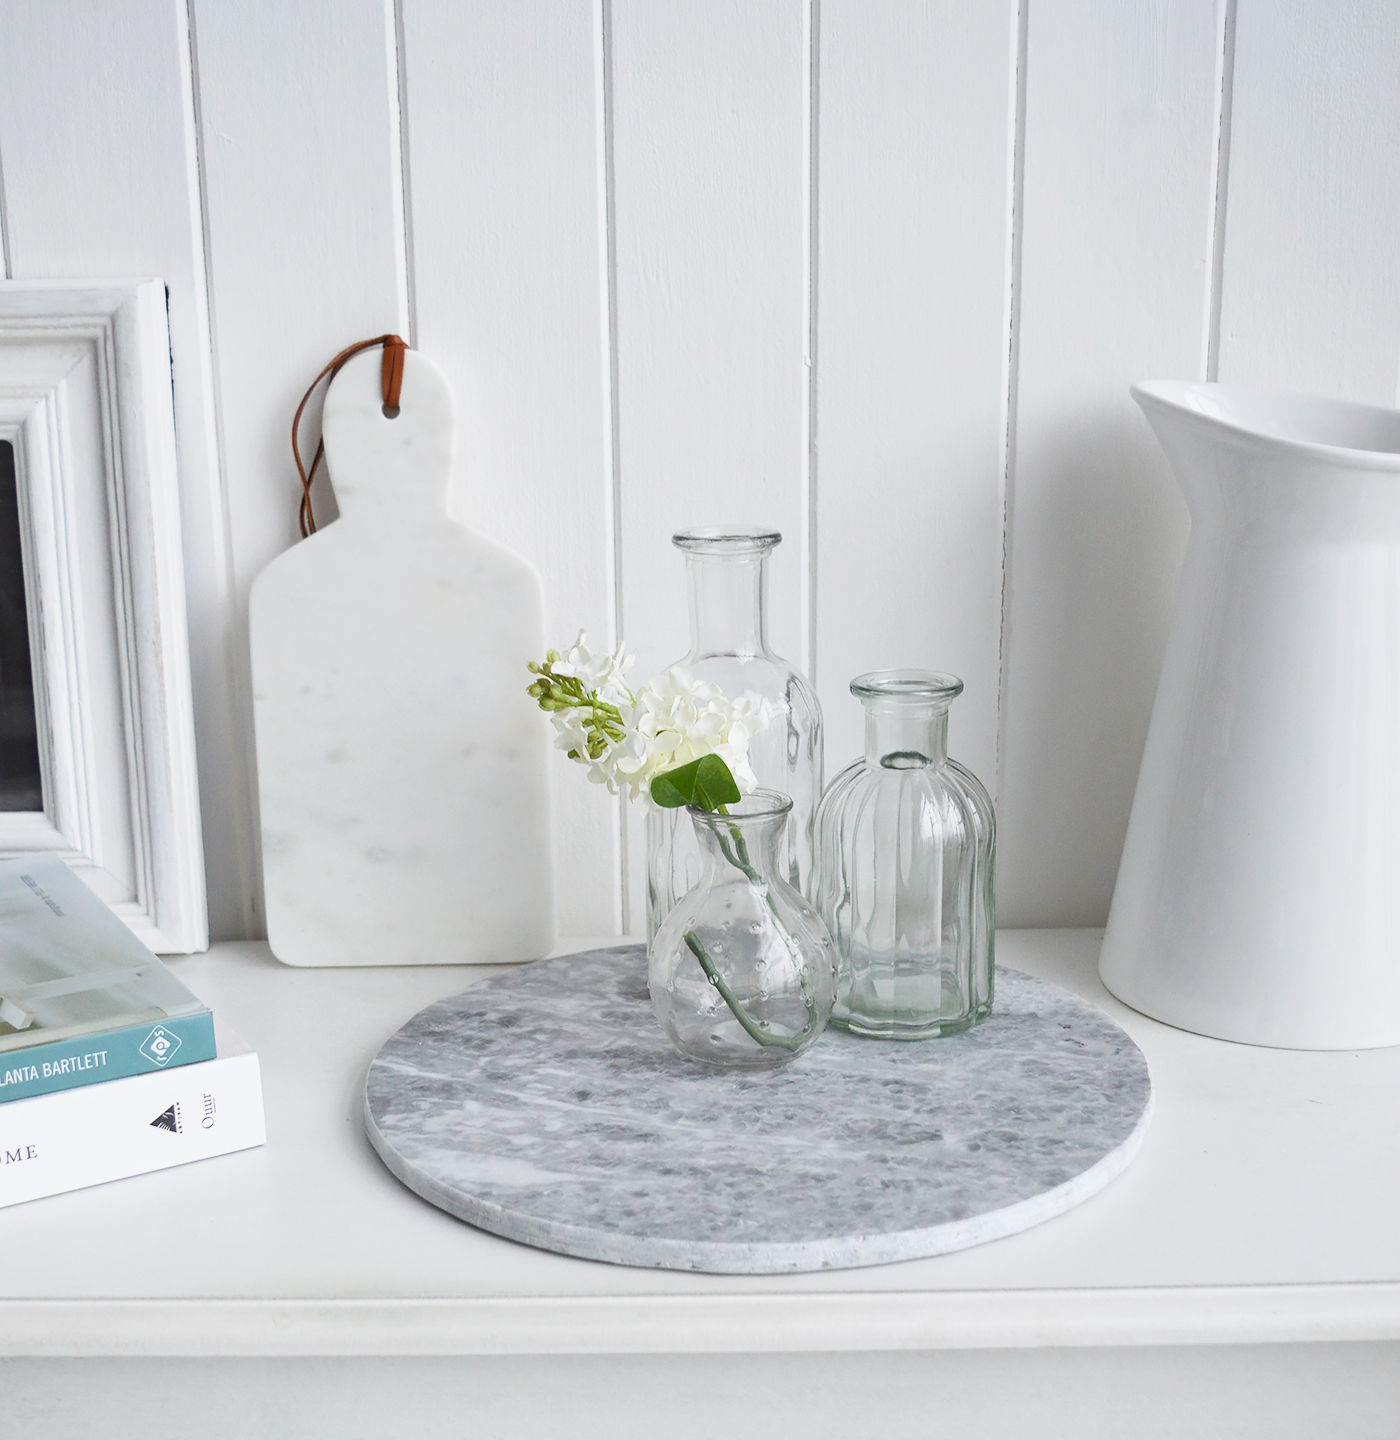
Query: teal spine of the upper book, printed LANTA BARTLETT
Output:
[[0, 1009, 215, 1104]]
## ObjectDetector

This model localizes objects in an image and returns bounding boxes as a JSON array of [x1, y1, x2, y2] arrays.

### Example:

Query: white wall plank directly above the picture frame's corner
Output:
[[0, 0, 256, 939]]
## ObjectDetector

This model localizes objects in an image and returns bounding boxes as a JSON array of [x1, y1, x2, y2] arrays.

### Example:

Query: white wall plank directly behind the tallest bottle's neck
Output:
[[612, 0, 808, 926]]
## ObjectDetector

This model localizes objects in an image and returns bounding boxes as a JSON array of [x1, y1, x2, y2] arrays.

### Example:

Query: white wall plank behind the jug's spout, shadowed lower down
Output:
[[997, 0, 1217, 924]]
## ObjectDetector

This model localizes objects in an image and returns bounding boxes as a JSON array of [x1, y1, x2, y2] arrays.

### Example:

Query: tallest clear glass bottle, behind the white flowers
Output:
[[647, 527, 821, 939]]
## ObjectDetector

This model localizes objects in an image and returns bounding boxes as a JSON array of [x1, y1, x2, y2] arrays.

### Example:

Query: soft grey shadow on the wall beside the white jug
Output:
[[997, 400, 1188, 926]]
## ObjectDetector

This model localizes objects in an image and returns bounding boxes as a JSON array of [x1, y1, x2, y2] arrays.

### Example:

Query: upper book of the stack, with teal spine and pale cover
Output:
[[0, 855, 215, 1103]]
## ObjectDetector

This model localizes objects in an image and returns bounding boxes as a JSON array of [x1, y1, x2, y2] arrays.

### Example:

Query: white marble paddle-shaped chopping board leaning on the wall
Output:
[[249, 350, 555, 965]]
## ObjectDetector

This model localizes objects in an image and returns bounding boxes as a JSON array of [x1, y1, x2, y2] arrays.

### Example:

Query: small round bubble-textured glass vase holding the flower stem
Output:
[[647, 791, 837, 1070]]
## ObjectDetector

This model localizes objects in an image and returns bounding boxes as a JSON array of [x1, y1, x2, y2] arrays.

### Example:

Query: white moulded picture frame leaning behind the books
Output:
[[0, 279, 209, 955]]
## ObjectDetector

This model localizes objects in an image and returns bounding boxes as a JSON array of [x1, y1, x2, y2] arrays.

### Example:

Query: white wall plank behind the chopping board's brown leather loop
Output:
[[193, 0, 408, 923]]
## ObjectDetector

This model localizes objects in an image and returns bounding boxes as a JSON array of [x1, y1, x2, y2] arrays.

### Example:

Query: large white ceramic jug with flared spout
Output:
[[1099, 382, 1400, 1050]]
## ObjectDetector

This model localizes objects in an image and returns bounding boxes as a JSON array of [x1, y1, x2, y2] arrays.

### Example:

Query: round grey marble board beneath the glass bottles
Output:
[[364, 945, 1152, 1274]]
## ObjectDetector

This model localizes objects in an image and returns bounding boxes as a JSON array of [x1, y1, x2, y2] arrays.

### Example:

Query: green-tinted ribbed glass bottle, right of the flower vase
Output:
[[814, 670, 995, 1040]]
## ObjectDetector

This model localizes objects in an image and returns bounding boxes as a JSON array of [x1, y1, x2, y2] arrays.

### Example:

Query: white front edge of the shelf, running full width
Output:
[[0, 1282, 1400, 1356]]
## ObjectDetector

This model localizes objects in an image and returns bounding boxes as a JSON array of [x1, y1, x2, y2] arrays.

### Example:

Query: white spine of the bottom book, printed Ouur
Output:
[[0, 1051, 266, 1208]]
